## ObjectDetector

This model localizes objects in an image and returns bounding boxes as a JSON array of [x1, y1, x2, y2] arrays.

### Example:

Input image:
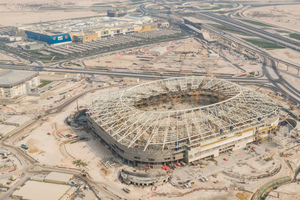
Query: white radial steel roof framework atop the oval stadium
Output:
[[87, 76, 278, 151]]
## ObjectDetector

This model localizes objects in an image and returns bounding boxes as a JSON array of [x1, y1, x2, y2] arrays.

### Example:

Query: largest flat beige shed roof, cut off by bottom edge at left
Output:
[[12, 181, 73, 200]]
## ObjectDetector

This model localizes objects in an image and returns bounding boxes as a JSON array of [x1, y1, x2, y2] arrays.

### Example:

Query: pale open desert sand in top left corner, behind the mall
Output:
[[0, 0, 125, 26]]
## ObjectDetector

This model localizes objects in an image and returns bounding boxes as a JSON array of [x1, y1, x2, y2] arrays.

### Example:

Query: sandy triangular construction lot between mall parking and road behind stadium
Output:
[[81, 38, 252, 76]]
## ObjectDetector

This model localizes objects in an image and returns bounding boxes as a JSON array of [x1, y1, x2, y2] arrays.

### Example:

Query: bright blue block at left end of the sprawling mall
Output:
[[25, 31, 72, 45]]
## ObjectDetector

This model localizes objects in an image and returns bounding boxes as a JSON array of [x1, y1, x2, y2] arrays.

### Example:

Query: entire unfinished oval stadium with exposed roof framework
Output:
[[87, 76, 279, 167]]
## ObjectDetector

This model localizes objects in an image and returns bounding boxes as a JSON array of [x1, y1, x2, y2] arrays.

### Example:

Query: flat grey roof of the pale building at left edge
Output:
[[0, 69, 39, 87]]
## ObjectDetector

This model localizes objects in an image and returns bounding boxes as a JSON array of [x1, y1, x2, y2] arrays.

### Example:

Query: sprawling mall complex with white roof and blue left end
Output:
[[18, 15, 161, 45]]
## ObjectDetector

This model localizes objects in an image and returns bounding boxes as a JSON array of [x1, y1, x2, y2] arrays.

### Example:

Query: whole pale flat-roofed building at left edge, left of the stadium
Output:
[[0, 69, 40, 99]]
